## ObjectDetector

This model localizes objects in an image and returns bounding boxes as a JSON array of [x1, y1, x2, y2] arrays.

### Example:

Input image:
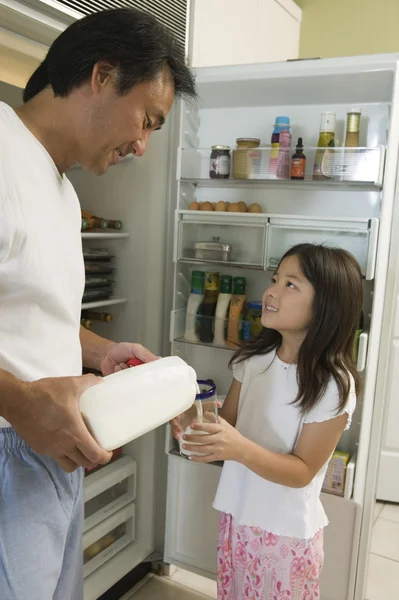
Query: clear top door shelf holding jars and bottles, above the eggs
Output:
[[177, 145, 385, 187]]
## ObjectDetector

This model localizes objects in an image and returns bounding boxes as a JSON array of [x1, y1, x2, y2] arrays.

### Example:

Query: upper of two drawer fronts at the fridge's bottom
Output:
[[84, 456, 136, 532]]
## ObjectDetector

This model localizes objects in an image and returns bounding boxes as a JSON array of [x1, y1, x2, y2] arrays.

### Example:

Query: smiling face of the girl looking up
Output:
[[261, 256, 314, 333]]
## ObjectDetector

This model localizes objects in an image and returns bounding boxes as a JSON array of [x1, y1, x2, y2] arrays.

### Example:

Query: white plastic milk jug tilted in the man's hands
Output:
[[80, 356, 199, 450]]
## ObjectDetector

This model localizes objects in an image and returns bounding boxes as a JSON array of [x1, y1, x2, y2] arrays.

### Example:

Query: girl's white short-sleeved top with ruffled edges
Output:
[[214, 351, 356, 539]]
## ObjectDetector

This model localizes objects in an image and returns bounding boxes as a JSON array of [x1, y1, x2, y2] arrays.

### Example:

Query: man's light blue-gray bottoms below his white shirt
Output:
[[0, 428, 83, 600]]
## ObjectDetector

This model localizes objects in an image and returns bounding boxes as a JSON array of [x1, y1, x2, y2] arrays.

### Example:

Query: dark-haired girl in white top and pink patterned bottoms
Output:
[[175, 244, 362, 600]]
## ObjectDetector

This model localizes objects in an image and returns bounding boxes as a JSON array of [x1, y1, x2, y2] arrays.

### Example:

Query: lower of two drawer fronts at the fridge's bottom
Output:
[[83, 503, 135, 577]]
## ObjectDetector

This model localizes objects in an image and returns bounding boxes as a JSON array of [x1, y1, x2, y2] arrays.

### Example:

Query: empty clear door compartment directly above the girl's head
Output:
[[266, 217, 379, 279]]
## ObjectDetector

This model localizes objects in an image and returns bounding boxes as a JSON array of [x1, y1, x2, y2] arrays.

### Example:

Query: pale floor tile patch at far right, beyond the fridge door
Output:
[[366, 503, 399, 600]]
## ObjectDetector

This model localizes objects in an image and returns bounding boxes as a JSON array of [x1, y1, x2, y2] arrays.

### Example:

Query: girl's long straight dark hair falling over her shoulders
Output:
[[230, 244, 363, 413]]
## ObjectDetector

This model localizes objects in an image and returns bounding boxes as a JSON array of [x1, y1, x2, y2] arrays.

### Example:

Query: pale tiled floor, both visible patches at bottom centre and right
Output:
[[124, 503, 399, 600]]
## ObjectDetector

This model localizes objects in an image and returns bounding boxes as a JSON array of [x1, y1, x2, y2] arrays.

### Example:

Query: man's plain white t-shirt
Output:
[[0, 102, 84, 427]]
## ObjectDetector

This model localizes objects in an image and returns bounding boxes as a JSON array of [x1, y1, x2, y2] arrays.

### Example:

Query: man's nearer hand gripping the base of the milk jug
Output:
[[4, 375, 112, 473]]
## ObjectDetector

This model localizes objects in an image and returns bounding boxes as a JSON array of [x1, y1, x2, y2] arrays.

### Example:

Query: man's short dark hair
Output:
[[24, 8, 196, 102]]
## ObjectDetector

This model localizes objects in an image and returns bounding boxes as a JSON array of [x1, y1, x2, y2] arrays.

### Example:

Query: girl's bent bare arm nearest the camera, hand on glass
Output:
[[184, 414, 348, 488]]
